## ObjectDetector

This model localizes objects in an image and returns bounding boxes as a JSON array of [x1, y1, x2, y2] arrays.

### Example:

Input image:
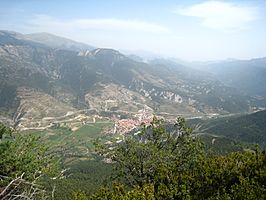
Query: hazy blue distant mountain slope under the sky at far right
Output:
[[190, 58, 266, 97]]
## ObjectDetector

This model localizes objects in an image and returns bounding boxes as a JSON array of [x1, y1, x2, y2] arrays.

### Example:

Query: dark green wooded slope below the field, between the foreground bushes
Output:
[[47, 160, 112, 200]]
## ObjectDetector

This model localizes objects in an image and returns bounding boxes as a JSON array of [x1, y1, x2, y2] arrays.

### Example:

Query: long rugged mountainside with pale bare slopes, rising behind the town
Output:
[[0, 31, 265, 128]]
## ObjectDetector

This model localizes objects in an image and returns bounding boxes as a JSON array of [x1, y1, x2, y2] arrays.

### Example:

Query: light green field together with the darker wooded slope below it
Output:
[[22, 122, 121, 200]]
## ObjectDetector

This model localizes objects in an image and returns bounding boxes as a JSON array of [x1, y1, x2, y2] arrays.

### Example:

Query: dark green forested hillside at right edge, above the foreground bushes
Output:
[[190, 110, 266, 147]]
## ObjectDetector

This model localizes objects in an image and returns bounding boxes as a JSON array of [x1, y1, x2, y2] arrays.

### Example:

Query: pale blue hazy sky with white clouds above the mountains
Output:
[[0, 0, 266, 60]]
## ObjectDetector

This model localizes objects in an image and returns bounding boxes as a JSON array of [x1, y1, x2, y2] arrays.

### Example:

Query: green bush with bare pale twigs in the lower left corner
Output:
[[0, 125, 58, 199]]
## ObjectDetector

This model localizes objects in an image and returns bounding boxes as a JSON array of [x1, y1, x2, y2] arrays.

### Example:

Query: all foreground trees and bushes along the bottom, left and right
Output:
[[0, 118, 266, 200]]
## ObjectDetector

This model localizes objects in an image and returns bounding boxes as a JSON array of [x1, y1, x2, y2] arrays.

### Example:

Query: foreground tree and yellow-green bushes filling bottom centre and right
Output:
[[91, 118, 266, 199]]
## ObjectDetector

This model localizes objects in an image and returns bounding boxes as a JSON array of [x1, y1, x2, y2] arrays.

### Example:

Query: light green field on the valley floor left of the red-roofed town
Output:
[[25, 122, 113, 161]]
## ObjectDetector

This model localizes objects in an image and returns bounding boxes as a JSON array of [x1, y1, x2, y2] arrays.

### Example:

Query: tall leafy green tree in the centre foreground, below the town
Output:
[[94, 118, 202, 198]]
